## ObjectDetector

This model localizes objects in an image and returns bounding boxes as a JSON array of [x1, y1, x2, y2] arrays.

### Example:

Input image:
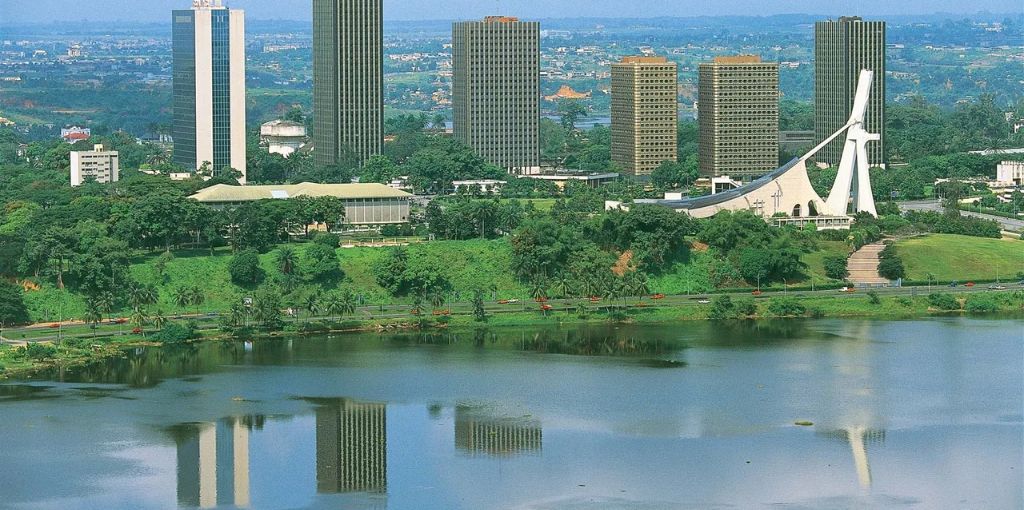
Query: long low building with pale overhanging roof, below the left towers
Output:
[[189, 182, 413, 226]]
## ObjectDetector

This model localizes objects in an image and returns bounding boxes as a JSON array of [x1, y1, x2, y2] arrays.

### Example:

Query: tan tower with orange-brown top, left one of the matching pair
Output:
[[611, 56, 679, 175]]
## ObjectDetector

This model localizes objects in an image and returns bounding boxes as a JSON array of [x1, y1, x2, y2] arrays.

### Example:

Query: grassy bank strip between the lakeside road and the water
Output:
[[0, 291, 1024, 378]]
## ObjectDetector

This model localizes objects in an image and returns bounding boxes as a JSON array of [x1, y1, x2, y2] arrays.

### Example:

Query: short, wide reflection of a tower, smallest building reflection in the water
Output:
[[455, 405, 544, 457]]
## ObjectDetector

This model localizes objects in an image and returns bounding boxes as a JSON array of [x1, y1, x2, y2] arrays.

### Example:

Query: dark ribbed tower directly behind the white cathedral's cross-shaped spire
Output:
[[814, 16, 886, 165]]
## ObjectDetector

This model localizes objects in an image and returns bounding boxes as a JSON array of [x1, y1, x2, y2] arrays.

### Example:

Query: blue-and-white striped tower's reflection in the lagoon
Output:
[[170, 416, 264, 508]]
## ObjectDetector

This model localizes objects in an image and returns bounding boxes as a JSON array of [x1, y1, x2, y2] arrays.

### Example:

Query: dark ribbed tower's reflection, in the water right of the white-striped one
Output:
[[313, 398, 387, 494]]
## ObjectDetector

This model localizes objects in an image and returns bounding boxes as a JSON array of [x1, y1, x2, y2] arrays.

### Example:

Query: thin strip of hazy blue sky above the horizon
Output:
[[0, 0, 1024, 22]]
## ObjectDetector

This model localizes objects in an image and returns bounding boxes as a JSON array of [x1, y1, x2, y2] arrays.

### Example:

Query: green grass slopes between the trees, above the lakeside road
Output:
[[16, 235, 1024, 322]]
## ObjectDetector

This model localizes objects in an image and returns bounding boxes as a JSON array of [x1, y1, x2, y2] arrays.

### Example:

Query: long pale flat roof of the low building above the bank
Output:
[[189, 182, 412, 203]]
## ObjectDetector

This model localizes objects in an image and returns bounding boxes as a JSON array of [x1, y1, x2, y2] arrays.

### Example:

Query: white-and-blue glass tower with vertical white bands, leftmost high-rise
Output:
[[171, 0, 246, 183]]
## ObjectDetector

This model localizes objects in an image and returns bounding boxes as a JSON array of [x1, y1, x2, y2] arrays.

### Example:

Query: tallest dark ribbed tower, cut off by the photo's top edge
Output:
[[312, 0, 384, 171]]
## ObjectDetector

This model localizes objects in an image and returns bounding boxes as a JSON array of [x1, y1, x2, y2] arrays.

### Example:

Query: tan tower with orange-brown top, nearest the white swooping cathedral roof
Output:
[[697, 55, 778, 180]]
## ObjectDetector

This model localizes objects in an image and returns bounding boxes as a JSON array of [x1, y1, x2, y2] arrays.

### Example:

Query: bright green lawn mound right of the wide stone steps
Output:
[[896, 233, 1024, 282]]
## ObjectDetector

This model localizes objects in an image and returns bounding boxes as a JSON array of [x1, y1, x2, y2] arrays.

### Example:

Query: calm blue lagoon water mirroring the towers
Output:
[[0, 318, 1024, 509]]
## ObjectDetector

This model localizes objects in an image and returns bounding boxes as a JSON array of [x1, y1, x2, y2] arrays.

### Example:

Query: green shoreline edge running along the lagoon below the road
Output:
[[0, 292, 1024, 381]]
